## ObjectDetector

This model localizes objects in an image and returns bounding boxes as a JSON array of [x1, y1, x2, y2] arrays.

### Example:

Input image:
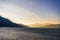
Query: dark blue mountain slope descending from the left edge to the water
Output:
[[0, 16, 24, 27]]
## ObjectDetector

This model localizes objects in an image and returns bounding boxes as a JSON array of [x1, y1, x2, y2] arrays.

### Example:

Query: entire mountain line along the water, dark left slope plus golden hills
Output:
[[0, 16, 60, 28]]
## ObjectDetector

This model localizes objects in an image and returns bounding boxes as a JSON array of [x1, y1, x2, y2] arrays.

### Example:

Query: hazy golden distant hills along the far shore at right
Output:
[[29, 23, 60, 28]]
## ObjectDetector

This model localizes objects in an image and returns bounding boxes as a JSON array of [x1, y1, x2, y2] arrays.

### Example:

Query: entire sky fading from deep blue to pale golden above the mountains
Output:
[[0, 0, 60, 25]]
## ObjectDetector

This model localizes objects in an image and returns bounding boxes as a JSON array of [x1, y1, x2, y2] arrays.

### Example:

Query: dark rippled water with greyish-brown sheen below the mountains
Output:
[[0, 27, 60, 40]]
